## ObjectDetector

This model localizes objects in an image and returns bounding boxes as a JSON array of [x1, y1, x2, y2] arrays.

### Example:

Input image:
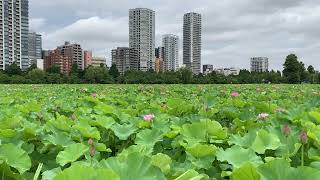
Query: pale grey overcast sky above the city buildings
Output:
[[29, 0, 320, 70]]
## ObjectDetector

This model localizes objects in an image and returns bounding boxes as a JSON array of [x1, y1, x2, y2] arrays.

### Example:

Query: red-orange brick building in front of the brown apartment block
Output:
[[43, 49, 72, 74]]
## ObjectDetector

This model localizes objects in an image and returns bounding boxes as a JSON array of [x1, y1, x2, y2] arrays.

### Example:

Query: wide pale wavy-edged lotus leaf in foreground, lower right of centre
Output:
[[217, 146, 262, 168]]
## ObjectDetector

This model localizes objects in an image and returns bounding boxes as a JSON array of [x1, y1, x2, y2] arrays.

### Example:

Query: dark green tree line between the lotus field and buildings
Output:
[[0, 54, 320, 84]]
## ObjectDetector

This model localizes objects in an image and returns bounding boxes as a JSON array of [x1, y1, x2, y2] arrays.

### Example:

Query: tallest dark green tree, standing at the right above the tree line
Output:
[[283, 54, 303, 84]]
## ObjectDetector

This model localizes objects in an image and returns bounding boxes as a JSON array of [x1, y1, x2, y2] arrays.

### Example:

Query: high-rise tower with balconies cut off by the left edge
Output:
[[0, 0, 29, 70]]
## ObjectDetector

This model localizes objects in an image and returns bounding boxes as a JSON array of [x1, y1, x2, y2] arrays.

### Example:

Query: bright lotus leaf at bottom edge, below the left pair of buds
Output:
[[53, 164, 120, 180]]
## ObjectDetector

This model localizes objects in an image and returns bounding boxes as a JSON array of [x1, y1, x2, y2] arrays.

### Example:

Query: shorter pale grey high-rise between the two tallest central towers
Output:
[[162, 34, 179, 71]]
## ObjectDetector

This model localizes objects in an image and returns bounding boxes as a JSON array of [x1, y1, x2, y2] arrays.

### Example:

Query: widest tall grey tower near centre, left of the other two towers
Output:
[[129, 8, 155, 71]]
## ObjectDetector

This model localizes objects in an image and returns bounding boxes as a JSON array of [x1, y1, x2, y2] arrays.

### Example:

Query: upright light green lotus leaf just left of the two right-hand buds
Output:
[[251, 130, 281, 154]]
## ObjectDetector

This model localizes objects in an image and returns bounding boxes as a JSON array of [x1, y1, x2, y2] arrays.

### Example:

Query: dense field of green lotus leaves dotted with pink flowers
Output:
[[0, 85, 320, 180]]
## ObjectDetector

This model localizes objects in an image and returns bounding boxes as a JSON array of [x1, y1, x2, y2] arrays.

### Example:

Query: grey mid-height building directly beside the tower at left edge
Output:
[[28, 32, 42, 65]]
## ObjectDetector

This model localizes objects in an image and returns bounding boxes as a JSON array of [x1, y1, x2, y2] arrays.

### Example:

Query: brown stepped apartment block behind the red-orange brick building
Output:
[[58, 42, 84, 69]]
